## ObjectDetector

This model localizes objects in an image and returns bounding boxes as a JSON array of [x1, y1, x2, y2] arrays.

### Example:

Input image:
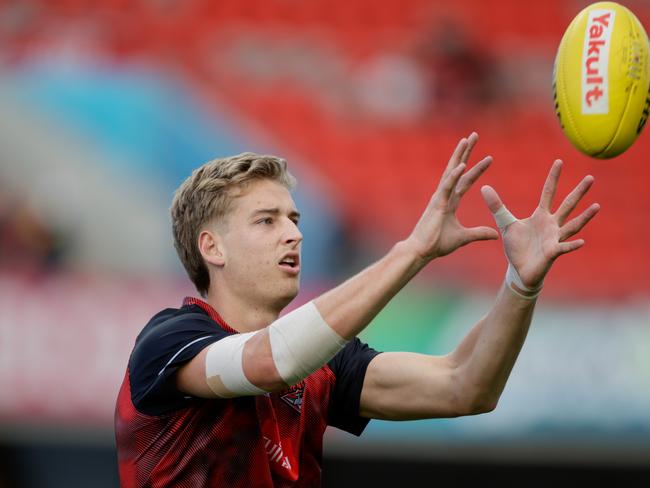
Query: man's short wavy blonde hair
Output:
[[170, 152, 296, 296]]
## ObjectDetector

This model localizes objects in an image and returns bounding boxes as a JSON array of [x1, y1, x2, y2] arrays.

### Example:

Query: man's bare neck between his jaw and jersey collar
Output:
[[205, 292, 281, 332]]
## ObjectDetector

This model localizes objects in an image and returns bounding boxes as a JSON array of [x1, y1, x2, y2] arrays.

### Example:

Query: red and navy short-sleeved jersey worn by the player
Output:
[[115, 298, 379, 488]]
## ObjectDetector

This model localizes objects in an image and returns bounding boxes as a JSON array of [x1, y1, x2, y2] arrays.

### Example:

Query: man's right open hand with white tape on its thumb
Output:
[[481, 160, 600, 290]]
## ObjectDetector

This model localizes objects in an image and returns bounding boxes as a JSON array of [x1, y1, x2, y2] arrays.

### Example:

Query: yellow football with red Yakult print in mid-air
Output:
[[553, 2, 650, 159]]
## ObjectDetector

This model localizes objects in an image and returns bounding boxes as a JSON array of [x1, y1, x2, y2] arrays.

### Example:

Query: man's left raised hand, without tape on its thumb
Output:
[[407, 132, 499, 261]]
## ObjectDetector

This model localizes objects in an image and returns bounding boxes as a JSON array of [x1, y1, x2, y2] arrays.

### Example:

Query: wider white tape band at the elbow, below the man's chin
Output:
[[269, 302, 347, 385]]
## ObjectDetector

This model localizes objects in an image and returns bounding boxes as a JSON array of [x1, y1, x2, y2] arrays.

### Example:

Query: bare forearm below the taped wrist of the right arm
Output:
[[451, 285, 535, 411]]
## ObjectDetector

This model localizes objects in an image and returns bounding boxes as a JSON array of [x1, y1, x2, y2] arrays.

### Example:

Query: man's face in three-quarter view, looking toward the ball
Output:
[[215, 180, 302, 309]]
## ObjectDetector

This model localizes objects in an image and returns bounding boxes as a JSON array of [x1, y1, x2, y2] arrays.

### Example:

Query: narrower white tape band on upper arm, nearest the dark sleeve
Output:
[[205, 332, 266, 398]]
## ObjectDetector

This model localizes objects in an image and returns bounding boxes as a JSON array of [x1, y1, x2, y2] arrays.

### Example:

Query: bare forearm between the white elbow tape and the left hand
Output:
[[314, 241, 427, 339]]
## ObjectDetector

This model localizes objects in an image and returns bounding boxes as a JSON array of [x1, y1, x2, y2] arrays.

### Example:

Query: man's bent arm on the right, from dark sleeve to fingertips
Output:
[[360, 161, 599, 420]]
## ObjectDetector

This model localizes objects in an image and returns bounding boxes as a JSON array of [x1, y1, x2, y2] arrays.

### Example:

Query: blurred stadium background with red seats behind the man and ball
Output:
[[0, 0, 650, 488]]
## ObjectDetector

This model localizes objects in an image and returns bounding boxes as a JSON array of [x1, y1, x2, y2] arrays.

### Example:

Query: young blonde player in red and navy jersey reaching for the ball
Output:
[[115, 133, 599, 487]]
